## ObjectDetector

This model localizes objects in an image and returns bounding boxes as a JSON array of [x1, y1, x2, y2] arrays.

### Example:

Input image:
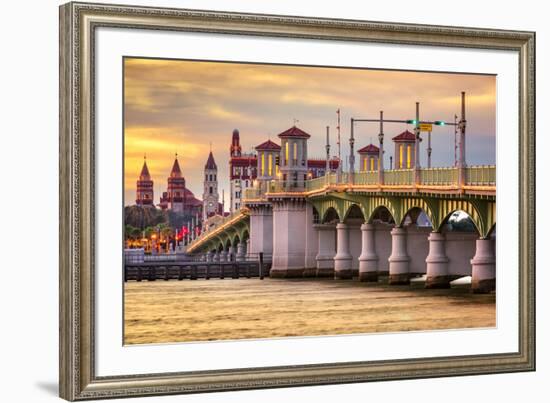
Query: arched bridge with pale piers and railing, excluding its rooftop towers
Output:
[[187, 166, 496, 292]]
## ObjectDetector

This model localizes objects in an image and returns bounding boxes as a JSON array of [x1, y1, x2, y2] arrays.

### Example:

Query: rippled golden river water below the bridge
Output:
[[124, 278, 496, 344]]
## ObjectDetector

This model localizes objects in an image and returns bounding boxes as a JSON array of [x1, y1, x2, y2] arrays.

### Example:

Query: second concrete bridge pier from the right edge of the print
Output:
[[426, 232, 452, 288]]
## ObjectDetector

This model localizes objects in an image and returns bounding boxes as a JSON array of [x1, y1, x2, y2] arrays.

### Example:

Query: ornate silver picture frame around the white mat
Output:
[[59, 3, 535, 401]]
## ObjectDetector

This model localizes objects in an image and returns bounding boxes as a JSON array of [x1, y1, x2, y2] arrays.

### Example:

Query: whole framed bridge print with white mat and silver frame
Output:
[[60, 3, 535, 400]]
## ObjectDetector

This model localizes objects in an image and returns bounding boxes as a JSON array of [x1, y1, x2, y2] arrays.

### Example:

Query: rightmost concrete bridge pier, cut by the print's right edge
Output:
[[470, 238, 496, 294]]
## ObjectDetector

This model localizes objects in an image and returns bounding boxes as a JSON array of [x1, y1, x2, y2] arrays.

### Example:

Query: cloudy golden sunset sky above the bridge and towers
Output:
[[124, 58, 496, 208]]
